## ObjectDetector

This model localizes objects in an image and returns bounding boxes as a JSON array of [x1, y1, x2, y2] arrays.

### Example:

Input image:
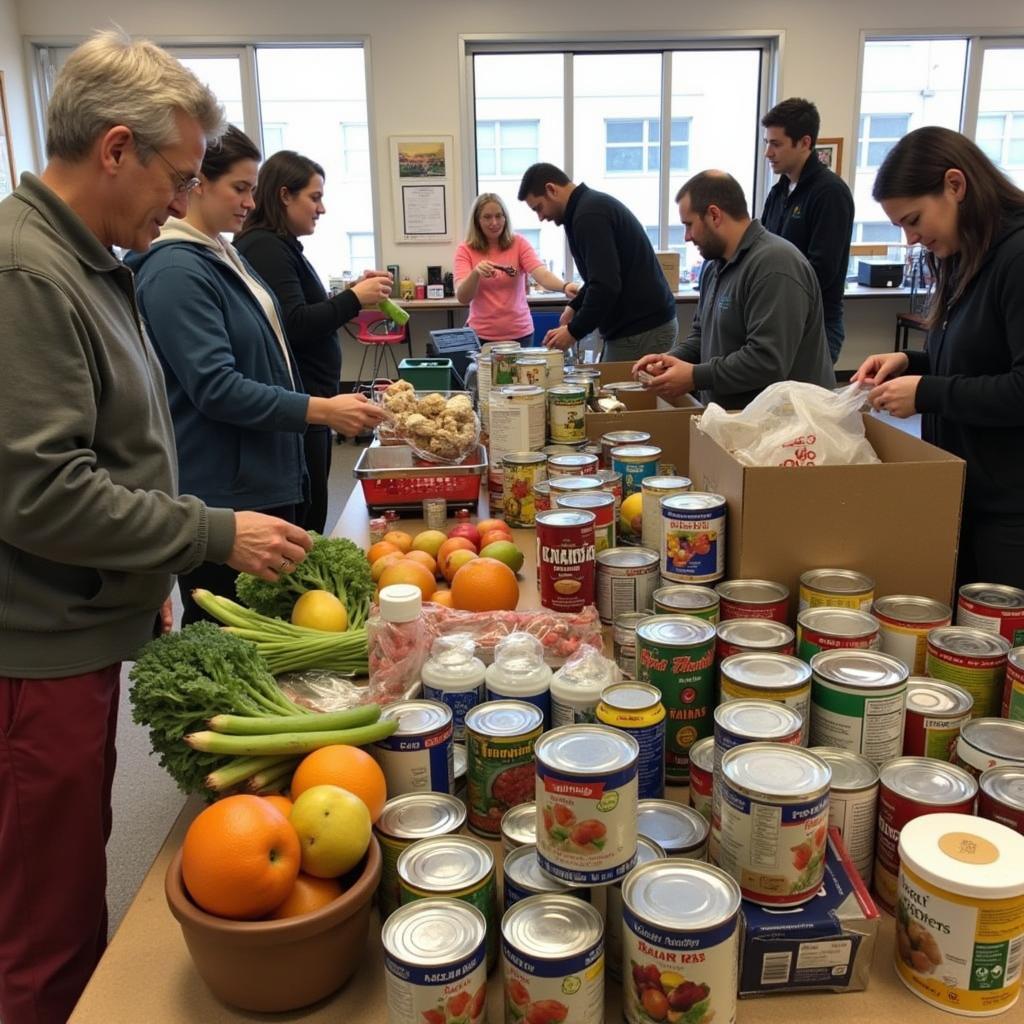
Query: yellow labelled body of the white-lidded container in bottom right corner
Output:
[[896, 864, 1024, 1015]]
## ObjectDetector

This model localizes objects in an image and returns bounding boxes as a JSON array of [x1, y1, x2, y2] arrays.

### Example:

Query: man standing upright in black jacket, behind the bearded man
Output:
[[761, 99, 853, 364]]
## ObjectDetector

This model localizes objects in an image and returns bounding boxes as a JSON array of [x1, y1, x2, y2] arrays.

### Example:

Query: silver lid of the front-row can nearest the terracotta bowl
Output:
[[381, 899, 487, 967]]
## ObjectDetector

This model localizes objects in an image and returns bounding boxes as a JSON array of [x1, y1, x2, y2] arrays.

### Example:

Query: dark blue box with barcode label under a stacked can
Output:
[[739, 828, 879, 996]]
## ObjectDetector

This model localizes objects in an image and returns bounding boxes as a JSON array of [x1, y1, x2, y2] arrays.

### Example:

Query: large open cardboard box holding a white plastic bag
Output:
[[689, 415, 965, 604]]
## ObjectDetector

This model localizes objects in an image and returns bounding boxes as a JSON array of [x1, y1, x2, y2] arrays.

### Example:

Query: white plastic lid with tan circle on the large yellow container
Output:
[[899, 813, 1024, 899]]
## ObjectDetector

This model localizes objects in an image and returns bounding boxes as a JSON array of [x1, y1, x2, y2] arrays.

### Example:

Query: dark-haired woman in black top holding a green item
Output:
[[234, 150, 391, 532]]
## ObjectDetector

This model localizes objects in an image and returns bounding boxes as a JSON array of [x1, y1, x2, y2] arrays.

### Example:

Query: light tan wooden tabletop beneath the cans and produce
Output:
[[70, 486, 933, 1024]]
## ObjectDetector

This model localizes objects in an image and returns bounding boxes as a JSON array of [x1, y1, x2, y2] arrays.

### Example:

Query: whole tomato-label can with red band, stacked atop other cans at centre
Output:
[[536, 725, 640, 886]]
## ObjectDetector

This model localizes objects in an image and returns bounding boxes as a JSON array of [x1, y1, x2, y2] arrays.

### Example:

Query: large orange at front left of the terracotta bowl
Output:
[[181, 790, 299, 921]]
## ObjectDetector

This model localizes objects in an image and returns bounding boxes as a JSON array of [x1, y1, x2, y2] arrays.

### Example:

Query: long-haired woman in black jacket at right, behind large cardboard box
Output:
[[853, 128, 1024, 587]]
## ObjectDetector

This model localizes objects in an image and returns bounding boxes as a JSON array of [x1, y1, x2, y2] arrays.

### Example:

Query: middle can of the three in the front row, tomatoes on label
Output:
[[502, 893, 604, 1022]]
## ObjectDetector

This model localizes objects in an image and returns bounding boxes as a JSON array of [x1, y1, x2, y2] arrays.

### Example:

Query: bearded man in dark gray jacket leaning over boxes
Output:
[[634, 171, 836, 409]]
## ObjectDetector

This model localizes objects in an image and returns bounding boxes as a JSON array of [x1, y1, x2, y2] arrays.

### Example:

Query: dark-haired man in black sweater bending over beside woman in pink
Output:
[[519, 164, 679, 359]]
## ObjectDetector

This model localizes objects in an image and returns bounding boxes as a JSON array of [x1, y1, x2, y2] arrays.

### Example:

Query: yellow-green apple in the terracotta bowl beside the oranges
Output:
[[289, 785, 372, 879]]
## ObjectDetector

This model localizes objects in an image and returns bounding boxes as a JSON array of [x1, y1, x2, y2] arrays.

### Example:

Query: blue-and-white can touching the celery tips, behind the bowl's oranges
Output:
[[370, 700, 455, 797]]
